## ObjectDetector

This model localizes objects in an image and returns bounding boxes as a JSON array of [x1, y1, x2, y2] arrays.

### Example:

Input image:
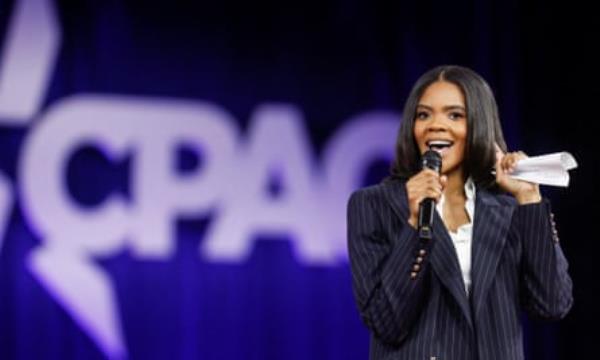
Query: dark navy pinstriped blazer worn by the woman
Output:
[[348, 180, 573, 360]]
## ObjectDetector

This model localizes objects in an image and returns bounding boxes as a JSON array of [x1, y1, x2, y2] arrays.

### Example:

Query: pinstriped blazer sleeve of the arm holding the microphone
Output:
[[347, 189, 432, 345]]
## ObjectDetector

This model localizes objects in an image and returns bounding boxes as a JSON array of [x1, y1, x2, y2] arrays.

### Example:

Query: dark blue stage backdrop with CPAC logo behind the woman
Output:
[[0, 0, 600, 359]]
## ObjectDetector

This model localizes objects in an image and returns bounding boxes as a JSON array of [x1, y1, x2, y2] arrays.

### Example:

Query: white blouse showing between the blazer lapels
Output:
[[436, 178, 475, 295]]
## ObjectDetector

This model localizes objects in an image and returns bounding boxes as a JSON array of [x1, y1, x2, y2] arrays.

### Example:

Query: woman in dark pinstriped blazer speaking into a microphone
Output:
[[348, 66, 573, 360]]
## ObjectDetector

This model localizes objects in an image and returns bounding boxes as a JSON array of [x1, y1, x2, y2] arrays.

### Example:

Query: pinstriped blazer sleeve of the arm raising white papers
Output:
[[515, 199, 573, 320]]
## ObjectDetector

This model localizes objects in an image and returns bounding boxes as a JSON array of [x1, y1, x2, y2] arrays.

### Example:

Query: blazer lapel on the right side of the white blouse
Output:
[[471, 190, 514, 316]]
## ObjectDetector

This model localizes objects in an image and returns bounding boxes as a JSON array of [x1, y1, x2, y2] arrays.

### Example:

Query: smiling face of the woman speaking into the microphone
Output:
[[414, 81, 467, 174]]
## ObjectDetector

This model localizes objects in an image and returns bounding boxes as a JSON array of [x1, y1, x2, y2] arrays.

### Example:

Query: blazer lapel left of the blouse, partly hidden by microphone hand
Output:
[[384, 181, 477, 326]]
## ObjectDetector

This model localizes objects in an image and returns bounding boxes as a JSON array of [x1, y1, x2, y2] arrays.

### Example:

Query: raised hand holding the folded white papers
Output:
[[496, 146, 542, 205]]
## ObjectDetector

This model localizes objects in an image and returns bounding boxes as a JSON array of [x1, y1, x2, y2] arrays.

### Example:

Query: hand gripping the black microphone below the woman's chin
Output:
[[406, 169, 447, 229]]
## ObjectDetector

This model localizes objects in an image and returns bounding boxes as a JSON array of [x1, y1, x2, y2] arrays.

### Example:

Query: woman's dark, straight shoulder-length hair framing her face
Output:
[[388, 65, 506, 189]]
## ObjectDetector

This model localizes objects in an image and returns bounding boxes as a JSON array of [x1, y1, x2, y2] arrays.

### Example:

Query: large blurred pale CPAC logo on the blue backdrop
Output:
[[0, 0, 399, 358]]
